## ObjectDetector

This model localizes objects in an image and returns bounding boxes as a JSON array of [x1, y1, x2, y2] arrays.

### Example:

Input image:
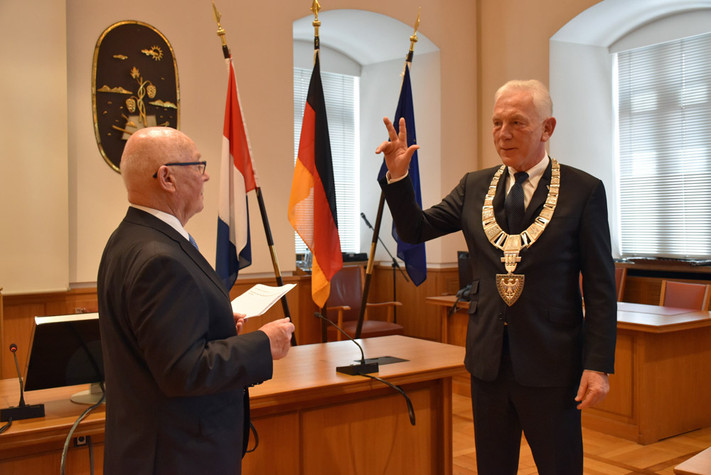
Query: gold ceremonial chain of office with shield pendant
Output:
[[481, 158, 560, 307]]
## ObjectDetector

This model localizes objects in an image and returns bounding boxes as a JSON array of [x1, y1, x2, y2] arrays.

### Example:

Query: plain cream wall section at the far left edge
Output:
[[0, 0, 69, 295]]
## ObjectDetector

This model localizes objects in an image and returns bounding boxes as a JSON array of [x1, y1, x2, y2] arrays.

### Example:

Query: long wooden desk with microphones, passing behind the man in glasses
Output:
[[0, 336, 464, 475]]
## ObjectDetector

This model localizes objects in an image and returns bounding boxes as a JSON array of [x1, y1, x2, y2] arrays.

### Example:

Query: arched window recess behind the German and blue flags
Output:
[[293, 9, 440, 259]]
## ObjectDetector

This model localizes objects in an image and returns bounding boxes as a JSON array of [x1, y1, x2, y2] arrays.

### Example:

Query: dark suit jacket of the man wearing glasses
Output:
[[97, 208, 272, 475]]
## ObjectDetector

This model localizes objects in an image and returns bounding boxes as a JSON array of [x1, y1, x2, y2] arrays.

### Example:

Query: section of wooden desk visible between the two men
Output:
[[243, 336, 464, 474]]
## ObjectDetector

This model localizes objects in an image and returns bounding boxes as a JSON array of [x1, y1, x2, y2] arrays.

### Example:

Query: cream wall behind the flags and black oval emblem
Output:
[[0, 0, 477, 293]]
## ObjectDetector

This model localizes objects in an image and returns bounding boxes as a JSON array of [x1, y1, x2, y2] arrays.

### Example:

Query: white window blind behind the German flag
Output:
[[294, 68, 360, 254]]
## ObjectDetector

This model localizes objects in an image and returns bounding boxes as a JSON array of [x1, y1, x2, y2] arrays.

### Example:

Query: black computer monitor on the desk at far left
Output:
[[25, 313, 104, 404]]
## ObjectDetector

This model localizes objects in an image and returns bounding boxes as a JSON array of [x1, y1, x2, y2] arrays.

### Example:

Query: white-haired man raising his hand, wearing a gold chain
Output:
[[376, 81, 617, 475]]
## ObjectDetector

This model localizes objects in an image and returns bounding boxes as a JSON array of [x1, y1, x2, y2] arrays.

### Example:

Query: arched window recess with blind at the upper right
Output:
[[550, 0, 711, 258]]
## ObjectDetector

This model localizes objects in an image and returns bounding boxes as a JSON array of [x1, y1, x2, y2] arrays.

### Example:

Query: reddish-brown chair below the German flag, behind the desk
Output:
[[326, 266, 405, 341]]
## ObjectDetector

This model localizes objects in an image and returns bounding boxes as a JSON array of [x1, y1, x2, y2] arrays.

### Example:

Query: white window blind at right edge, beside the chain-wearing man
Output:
[[617, 34, 711, 258]]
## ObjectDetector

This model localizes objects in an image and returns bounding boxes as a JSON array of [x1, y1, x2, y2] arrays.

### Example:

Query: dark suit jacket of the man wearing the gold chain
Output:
[[381, 158, 617, 386]]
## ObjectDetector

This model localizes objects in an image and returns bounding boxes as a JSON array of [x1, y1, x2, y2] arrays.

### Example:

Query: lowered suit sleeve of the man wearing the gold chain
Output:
[[580, 182, 617, 373]]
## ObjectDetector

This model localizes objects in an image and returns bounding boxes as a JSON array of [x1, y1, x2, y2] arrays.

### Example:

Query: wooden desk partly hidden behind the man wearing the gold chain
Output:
[[427, 296, 711, 444]]
